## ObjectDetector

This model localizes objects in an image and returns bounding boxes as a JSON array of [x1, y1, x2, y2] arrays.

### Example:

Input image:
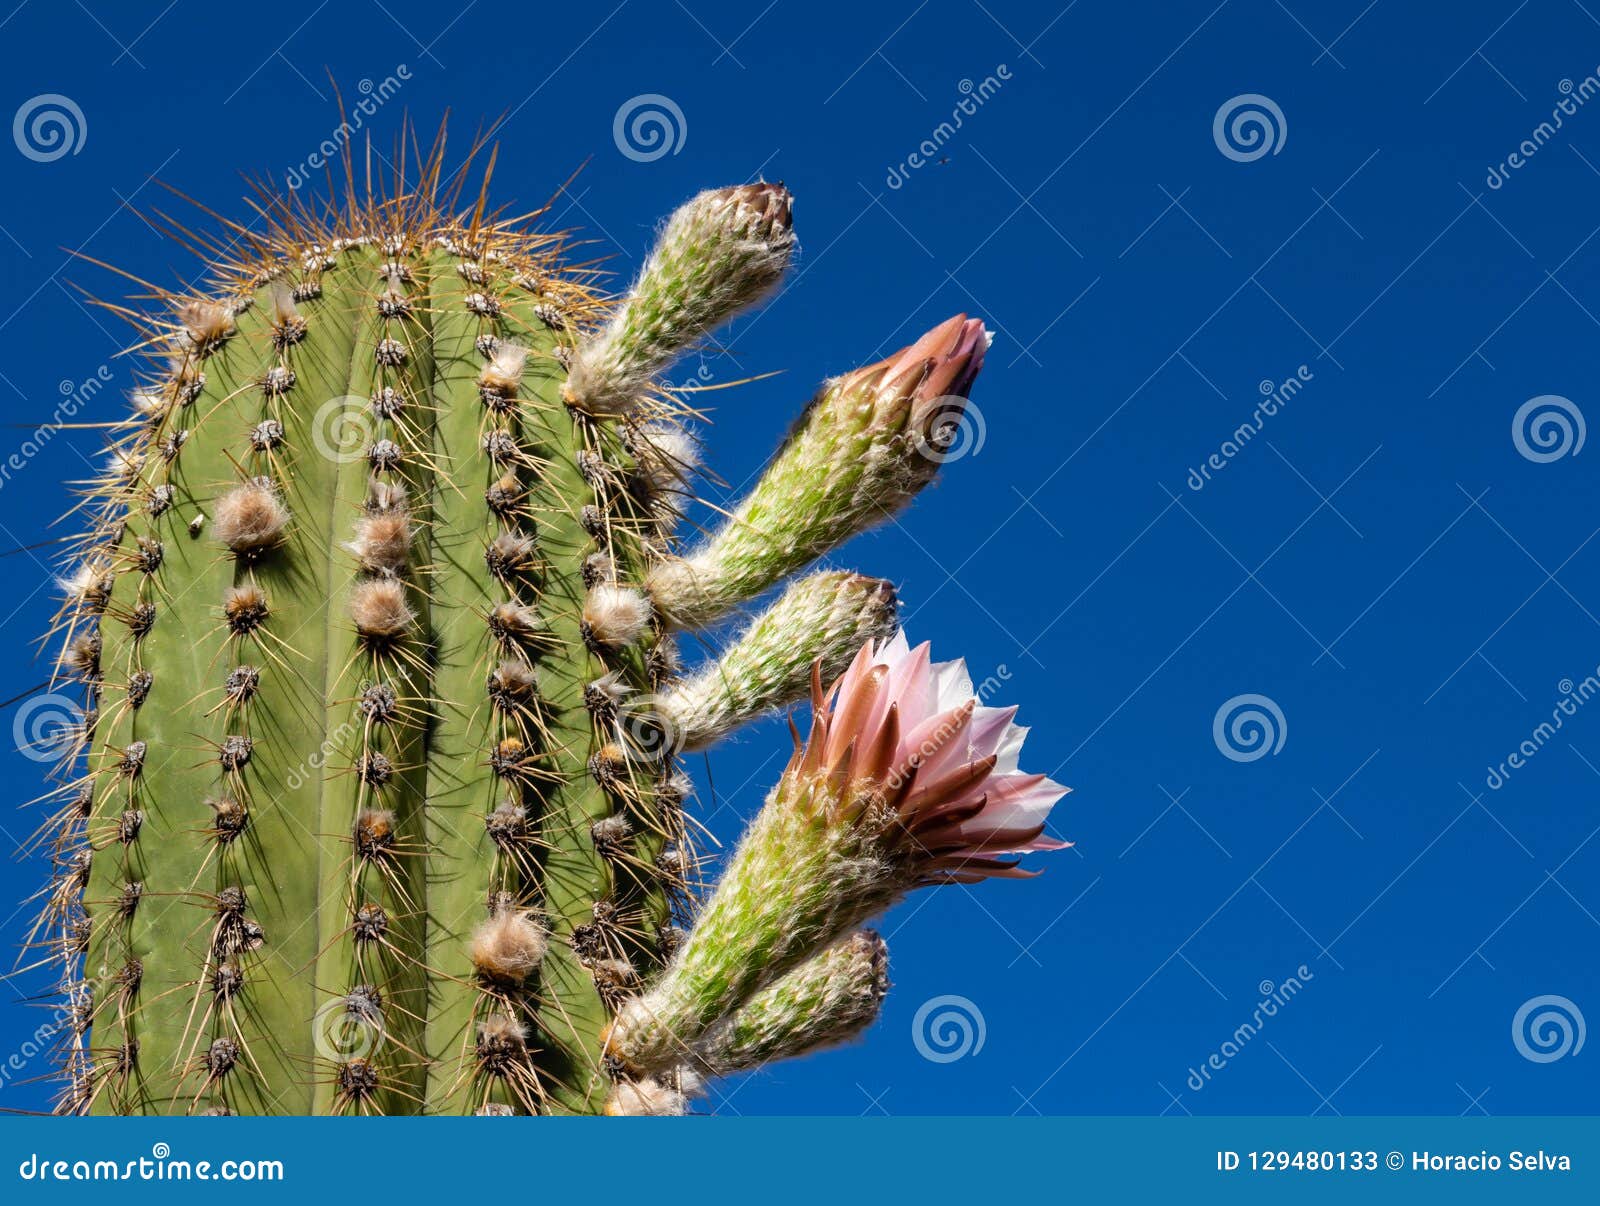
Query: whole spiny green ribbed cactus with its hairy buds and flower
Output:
[[37, 139, 1061, 1113]]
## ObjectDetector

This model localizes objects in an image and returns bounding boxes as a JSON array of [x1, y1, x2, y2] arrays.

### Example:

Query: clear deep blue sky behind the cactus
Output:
[[0, 0, 1600, 1115]]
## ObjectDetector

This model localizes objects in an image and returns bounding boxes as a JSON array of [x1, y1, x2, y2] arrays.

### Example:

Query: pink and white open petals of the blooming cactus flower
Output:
[[790, 633, 1070, 883]]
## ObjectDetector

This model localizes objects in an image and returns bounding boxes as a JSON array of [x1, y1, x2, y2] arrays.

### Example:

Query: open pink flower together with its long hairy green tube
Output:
[[606, 633, 1066, 1072]]
